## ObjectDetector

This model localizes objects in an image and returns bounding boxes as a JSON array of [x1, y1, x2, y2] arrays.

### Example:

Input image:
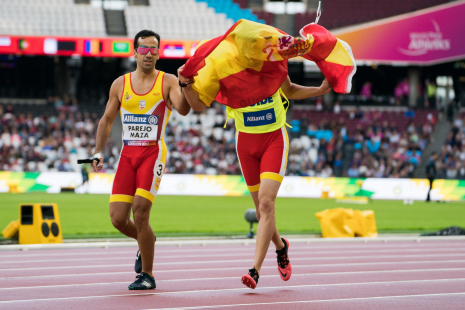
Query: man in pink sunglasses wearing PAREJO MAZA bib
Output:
[[92, 30, 190, 290]]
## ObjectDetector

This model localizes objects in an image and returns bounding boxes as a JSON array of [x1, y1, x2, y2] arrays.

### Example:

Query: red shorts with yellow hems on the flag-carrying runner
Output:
[[236, 127, 289, 192]]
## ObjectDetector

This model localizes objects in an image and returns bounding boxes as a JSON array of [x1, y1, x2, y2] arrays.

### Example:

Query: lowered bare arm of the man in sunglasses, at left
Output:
[[92, 76, 124, 172]]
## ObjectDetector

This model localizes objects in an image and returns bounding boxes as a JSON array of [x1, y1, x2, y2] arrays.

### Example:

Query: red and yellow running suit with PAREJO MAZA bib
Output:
[[110, 71, 171, 203]]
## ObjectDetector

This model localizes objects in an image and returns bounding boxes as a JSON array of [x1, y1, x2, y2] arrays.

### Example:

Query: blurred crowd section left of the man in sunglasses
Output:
[[0, 101, 119, 172]]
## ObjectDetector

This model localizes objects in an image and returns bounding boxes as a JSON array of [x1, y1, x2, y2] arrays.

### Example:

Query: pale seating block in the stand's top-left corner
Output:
[[0, 0, 106, 37]]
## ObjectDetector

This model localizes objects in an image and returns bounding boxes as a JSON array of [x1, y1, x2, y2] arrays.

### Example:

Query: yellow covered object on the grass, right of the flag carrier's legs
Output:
[[315, 208, 378, 238]]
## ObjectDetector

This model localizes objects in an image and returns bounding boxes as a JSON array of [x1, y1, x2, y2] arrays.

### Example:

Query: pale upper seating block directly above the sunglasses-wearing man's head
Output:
[[125, 0, 234, 40]]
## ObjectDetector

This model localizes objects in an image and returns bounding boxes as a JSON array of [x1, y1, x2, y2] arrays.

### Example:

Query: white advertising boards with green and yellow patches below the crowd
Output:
[[0, 171, 465, 201]]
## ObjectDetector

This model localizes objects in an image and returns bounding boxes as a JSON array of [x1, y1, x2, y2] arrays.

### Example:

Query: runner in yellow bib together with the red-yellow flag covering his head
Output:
[[178, 20, 356, 288]]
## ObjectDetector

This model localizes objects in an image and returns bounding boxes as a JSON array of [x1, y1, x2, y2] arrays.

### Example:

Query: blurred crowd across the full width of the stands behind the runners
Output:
[[0, 97, 446, 178]]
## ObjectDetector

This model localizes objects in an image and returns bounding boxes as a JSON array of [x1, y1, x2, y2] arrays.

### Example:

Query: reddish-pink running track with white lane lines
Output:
[[0, 239, 465, 310]]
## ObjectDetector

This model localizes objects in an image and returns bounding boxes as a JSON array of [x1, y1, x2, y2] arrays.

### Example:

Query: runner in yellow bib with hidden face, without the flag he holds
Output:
[[178, 67, 331, 289]]
